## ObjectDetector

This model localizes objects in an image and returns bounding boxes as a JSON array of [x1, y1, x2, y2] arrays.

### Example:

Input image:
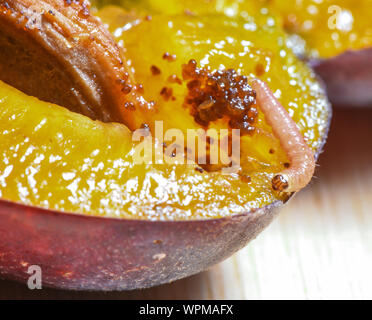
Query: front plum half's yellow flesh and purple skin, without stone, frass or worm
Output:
[[0, 0, 330, 290]]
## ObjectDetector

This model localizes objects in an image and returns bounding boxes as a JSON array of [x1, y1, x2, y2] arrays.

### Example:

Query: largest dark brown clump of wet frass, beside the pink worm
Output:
[[182, 60, 258, 135]]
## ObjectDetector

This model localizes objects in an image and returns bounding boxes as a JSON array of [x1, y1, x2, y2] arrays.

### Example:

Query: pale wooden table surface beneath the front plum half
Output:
[[0, 109, 372, 299]]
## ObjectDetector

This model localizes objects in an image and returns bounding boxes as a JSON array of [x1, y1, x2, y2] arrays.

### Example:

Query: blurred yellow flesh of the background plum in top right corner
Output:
[[268, 0, 372, 58]]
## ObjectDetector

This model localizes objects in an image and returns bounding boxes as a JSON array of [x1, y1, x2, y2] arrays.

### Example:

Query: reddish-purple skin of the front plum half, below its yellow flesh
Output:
[[0, 201, 281, 291]]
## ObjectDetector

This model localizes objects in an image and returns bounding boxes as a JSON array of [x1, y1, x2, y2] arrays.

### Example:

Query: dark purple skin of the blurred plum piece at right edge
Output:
[[310, 48, 372, 107]]
